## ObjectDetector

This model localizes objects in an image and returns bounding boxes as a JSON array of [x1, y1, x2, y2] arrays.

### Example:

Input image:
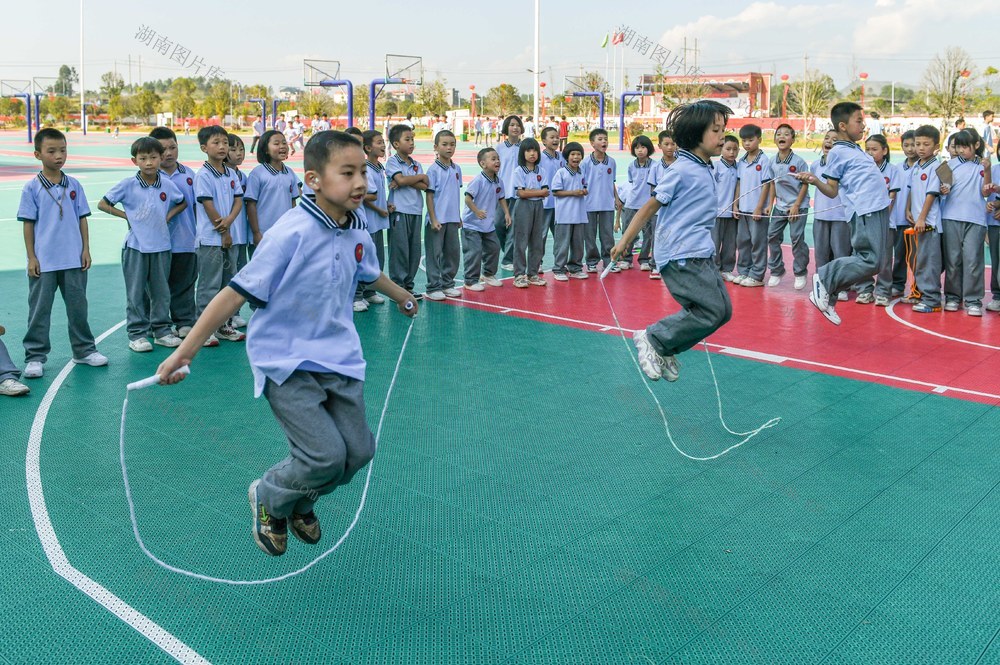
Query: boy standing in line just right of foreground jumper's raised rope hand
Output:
[[424, 129, 462, 300]]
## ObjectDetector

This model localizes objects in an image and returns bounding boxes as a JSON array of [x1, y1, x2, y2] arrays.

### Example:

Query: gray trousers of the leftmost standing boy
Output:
[[23, 268, 97, 364]]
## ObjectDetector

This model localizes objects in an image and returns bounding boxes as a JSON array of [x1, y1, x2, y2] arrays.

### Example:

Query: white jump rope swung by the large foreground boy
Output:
[[118, 302, 413, 586]]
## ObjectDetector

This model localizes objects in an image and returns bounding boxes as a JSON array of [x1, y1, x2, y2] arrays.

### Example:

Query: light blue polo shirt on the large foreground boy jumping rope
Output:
[[230, 198, 381, 397]]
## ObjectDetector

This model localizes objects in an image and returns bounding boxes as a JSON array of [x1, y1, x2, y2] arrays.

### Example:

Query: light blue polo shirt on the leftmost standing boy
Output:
[[17, 172, 90, 272]]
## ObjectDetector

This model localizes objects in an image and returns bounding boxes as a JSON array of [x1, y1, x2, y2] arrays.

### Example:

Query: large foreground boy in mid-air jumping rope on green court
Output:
[[157, 131, 417, 556]]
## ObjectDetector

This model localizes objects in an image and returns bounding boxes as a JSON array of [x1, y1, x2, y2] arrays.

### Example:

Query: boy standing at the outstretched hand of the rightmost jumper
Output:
[[767, 122, 809, 290]]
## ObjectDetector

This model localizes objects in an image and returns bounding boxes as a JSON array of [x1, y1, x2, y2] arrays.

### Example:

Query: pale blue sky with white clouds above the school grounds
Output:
[[0, 0, 1000, 94]]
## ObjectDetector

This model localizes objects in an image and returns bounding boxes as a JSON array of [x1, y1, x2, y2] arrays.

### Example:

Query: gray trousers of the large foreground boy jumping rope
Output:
[[258, 370, 375, 518]]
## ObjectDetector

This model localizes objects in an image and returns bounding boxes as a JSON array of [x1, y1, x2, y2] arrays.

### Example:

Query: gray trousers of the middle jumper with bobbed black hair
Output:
[[646, 257, 733, 356]]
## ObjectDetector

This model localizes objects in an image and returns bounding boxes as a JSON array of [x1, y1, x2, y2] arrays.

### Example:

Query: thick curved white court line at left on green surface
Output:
[[25, 321, 209, 664]]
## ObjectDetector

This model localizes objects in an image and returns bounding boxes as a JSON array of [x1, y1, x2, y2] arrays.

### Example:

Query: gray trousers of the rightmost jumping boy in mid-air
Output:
[[817, 208, 889, 305]]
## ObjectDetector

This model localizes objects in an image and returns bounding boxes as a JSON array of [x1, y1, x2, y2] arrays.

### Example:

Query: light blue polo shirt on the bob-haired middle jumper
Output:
[[653, 150, 718, 266]]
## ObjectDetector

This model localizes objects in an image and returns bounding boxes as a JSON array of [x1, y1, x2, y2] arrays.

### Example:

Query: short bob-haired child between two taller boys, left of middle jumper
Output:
[[552, 141, 590, 282]]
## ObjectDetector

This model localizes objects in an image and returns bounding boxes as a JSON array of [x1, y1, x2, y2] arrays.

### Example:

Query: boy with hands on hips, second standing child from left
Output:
[[97, 136, 187, 353]]
